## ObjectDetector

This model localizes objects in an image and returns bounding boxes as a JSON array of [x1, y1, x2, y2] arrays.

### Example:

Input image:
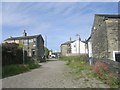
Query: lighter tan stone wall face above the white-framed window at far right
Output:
[[106, 19, 119, 60]]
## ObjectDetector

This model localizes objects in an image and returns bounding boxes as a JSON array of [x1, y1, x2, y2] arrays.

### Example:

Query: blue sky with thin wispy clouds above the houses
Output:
[[0, 2, 118, 51]]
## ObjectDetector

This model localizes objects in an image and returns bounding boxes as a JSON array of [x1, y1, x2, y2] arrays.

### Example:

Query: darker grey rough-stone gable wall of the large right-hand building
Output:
[[91, 16, 107, 58]]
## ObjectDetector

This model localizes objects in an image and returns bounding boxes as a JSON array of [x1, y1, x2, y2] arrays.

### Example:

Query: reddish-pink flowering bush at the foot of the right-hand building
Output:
[[92, 61, 120, 87]]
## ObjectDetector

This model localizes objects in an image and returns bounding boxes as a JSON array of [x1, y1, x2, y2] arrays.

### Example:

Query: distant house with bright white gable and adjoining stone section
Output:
[[61, 40, 87, 56]]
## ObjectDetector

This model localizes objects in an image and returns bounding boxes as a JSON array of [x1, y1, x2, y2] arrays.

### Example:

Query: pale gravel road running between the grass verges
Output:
[[2, 60, 109, 88]]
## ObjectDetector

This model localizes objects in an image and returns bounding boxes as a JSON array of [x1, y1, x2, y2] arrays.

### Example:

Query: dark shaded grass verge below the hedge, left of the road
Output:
[[2, 61, 40, 78]]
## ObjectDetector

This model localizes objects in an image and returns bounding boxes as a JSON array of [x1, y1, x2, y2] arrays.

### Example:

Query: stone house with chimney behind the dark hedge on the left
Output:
[[4, 30, 45, 61]]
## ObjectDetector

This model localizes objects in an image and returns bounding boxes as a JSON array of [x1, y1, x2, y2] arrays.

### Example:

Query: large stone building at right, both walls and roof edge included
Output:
[[91, 14, 120, 61]]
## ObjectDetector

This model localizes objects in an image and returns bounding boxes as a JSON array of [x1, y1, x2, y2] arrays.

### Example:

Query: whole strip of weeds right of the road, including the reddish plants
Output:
[[62, 56, 120, 88]]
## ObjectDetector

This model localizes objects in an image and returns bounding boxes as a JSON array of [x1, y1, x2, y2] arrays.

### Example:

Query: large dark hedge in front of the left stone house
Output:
[[2, 43, 27, 66]]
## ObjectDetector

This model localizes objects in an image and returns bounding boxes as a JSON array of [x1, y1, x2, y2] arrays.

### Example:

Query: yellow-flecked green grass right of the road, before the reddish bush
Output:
[[60, 56, 93, 78]]
